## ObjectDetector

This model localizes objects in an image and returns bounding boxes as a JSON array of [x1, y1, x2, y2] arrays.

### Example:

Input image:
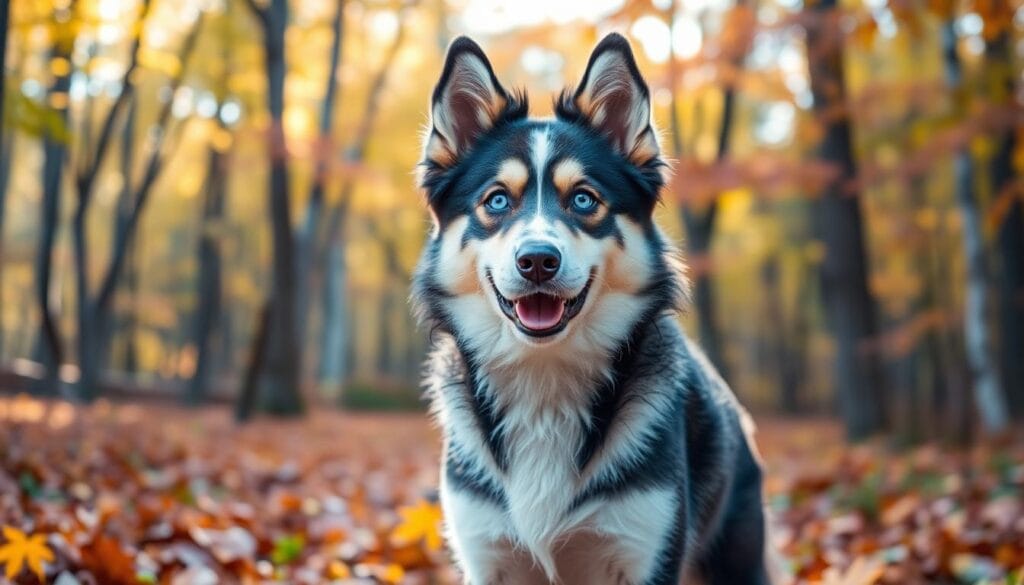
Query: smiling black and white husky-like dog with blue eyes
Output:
[[412, 34, 770, 585]]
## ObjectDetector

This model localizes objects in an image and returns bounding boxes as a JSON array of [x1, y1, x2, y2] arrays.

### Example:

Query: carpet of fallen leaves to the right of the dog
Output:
[[766, 428, 1024, 585]]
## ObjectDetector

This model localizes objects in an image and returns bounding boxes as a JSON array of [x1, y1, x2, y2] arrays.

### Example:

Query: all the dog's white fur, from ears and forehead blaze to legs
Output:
[[417, 36, 770, 585]]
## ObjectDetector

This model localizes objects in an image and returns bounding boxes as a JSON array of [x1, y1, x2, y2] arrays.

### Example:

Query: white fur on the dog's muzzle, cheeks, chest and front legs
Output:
[[428, 204, 674, 585]]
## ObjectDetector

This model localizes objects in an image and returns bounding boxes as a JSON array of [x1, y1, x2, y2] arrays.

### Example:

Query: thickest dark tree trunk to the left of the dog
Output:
[[262, 0, 304, 416]]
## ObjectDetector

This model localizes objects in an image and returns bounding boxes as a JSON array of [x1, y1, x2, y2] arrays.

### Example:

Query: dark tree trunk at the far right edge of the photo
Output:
[[985, 31, 1024, 418]]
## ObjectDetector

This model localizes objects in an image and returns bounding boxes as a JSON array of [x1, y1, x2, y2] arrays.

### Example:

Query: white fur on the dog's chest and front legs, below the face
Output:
[[433, 347, 676, 585]]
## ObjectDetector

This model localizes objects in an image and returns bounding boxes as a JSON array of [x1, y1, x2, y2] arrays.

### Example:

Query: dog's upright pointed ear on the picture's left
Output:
[[423, 37, 509, 168]]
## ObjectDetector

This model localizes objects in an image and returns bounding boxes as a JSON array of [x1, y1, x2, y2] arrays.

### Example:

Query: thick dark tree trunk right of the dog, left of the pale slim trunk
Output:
[[807, 0, 885, 440]]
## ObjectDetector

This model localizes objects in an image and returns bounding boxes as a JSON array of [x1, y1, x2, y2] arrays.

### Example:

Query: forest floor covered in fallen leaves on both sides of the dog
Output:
[[0, 396, 1024, 585]]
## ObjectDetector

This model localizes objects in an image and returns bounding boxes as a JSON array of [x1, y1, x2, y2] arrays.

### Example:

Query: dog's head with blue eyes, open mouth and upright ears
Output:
[[414, 35, 683, 362]]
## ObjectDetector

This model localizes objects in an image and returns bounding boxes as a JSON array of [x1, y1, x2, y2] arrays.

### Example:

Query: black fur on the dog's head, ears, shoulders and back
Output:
[[413, 35, 768, 585]]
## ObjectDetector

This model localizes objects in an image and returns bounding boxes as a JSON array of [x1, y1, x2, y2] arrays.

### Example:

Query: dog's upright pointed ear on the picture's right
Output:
[[556, 33, 660, 165]]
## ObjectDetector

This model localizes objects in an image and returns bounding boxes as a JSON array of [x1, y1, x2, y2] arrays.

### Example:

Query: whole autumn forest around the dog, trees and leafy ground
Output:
[[0, 0, 1024, 585]]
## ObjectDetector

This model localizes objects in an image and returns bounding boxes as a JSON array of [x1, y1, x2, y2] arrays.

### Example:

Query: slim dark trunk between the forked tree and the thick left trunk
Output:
[[185, 137, 227, 406]]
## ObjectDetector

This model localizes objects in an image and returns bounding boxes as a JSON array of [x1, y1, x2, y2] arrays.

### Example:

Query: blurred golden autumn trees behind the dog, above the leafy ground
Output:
[[0, 0, 1024, 441]]
